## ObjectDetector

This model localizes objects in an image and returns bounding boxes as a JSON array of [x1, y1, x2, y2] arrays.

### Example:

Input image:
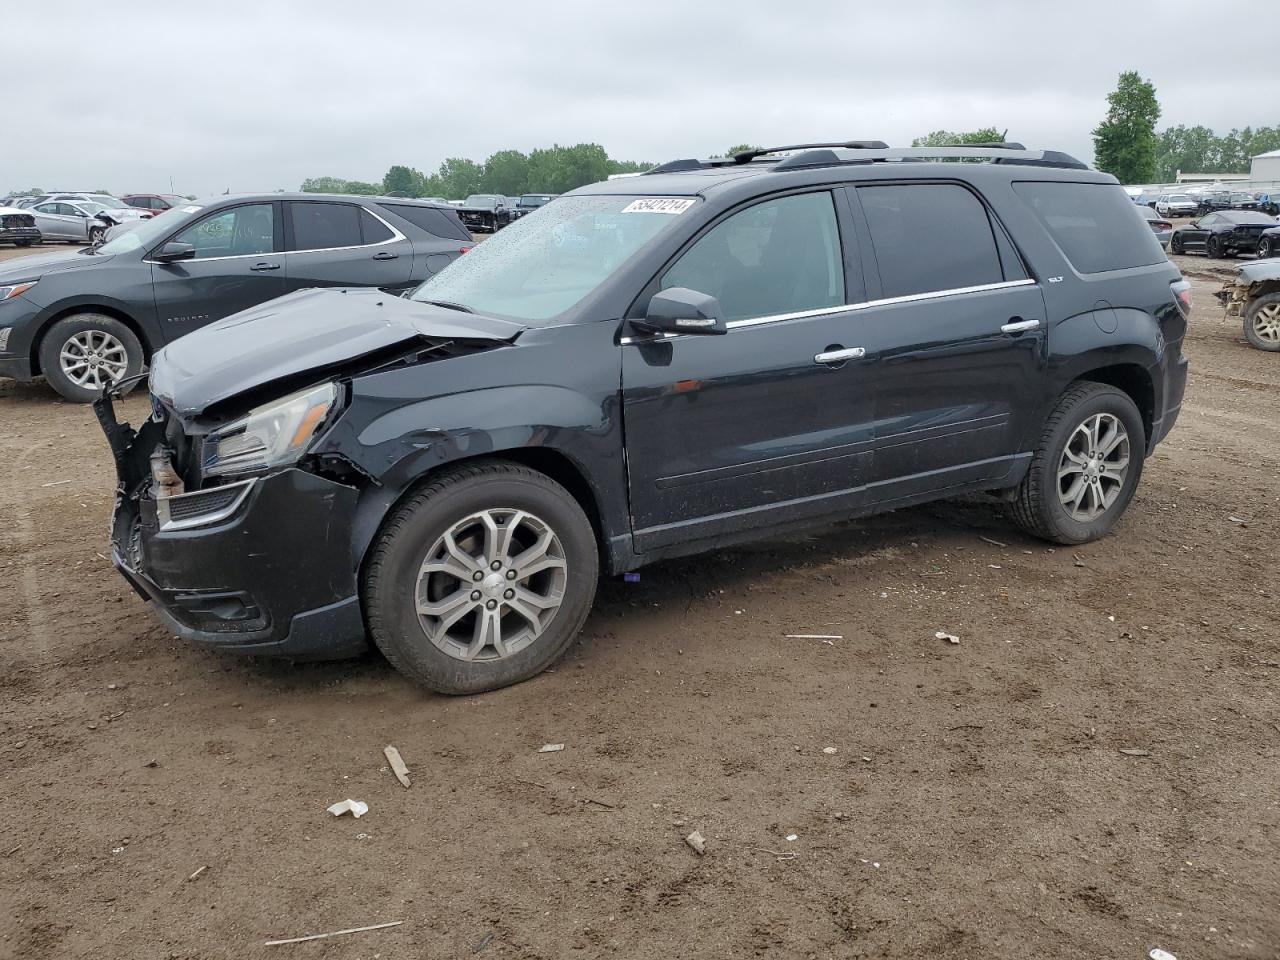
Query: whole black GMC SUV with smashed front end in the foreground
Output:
[[97, 143, 1190, 694]]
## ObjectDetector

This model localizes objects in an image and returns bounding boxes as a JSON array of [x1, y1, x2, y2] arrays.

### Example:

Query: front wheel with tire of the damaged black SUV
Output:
[[364, 461, 599, 695]]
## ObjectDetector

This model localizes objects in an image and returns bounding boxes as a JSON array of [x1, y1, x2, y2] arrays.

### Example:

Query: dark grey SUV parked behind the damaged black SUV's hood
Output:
[[0, 193, 471, 403]]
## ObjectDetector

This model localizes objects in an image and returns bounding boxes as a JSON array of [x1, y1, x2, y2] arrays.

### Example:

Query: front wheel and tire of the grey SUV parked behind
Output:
[[40, 314, 142, 403]]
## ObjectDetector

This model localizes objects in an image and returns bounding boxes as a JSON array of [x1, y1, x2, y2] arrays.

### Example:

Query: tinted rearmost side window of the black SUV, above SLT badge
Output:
[[1014, 180, 1167, 274]]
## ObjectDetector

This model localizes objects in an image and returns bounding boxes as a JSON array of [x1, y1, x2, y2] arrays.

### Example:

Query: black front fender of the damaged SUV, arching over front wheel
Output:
[[314, 324, 630, 564]]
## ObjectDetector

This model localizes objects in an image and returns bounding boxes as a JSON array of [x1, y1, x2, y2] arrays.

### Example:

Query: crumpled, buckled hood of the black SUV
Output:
[[151, 289, 525, 417]]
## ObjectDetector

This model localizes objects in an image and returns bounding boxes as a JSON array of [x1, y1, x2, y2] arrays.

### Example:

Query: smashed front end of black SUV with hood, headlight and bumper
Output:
[[93, 291, 522, 659]]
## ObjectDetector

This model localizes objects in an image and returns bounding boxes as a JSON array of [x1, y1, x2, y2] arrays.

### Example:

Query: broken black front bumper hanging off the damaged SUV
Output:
[[93, 397, 367, 659]]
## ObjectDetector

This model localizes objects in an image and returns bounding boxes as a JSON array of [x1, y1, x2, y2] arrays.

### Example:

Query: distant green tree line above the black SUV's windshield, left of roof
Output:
[[302, 143, 653, 200]]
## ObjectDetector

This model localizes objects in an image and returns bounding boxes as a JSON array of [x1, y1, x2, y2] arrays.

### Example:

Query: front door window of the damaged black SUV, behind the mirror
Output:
[[662, 192, 845, 320]]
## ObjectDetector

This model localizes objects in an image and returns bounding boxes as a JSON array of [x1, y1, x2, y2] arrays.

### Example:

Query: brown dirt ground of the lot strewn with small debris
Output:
[[0, 241, 1280, 960]]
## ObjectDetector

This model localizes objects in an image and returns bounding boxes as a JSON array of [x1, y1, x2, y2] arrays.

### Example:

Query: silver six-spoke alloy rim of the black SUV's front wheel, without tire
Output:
[[415, 507, 568, 660]]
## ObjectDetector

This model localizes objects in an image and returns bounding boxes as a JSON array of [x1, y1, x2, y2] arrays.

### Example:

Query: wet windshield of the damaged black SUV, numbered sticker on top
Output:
[[411, 196, 696, 320]]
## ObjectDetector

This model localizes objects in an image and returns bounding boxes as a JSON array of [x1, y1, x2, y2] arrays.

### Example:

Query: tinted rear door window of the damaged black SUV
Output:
[[858, 183, 1005, 297]]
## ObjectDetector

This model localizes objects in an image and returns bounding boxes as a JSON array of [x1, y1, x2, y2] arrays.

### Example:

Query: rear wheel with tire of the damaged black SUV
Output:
[[1012, 381, 1147, 544]]
